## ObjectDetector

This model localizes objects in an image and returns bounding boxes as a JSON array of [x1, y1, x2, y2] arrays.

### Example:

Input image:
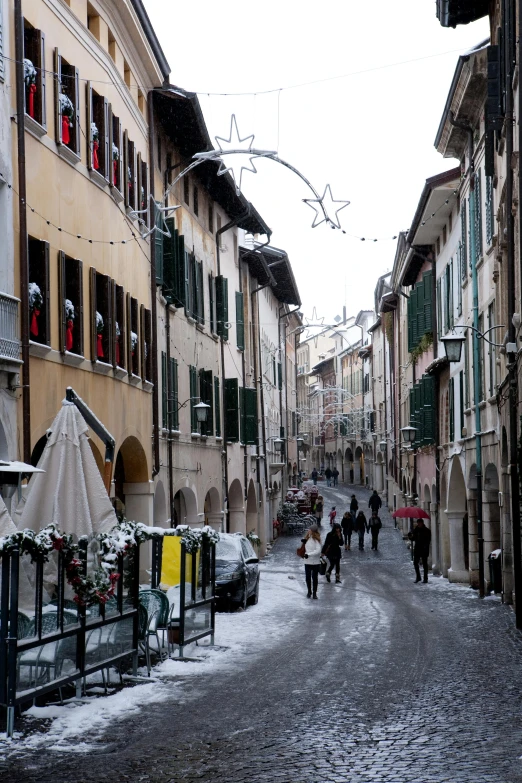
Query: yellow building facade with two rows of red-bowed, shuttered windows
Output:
[[9, 0, 168, 522]]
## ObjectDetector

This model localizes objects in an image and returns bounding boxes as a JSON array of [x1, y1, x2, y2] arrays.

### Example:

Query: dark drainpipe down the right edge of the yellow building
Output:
[[147, 91, 158, 480]]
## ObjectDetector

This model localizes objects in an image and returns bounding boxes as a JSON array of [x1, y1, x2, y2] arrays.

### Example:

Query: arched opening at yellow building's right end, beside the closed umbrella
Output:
[[113, 435, 154, 525]]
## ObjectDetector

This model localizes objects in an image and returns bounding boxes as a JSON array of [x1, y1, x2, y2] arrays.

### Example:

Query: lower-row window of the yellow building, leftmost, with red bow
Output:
[[28, 237, 51, 345]]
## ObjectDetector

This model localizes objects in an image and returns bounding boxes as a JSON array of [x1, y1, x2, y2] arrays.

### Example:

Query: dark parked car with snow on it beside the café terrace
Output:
[[216, 533, 259, 609]]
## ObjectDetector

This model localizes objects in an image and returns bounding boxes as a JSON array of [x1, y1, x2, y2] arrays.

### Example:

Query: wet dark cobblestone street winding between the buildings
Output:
[[0, 487, 522, 783]]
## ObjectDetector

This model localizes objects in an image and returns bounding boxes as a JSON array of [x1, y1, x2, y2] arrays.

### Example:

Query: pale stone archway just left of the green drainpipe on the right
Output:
[[446, 457, 469, 583]]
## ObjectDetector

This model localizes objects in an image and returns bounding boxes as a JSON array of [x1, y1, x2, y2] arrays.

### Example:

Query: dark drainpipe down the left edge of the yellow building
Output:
[[14, 0, 31, 462]]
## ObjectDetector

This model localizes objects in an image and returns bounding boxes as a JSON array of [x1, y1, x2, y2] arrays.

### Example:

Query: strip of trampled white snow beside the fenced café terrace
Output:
[[0, 564, 296, 753]]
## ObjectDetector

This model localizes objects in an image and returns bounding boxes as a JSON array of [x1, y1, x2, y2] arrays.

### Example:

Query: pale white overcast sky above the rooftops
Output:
[[145, 0, 489, 323]]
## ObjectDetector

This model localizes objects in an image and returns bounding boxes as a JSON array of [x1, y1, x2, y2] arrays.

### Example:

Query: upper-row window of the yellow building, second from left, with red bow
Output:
[[54, 48, 81, 156]]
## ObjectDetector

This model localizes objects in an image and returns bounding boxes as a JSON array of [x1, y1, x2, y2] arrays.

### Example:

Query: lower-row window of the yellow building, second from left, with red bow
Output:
[[58, 250, 83, 356]]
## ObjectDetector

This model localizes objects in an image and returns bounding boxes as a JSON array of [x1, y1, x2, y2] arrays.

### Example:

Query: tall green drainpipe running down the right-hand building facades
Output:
[[449, 112, 484, 598]]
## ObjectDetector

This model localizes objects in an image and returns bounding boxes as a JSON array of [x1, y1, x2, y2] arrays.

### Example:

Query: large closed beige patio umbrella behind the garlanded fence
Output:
[[16, 400, 117, 537]]
